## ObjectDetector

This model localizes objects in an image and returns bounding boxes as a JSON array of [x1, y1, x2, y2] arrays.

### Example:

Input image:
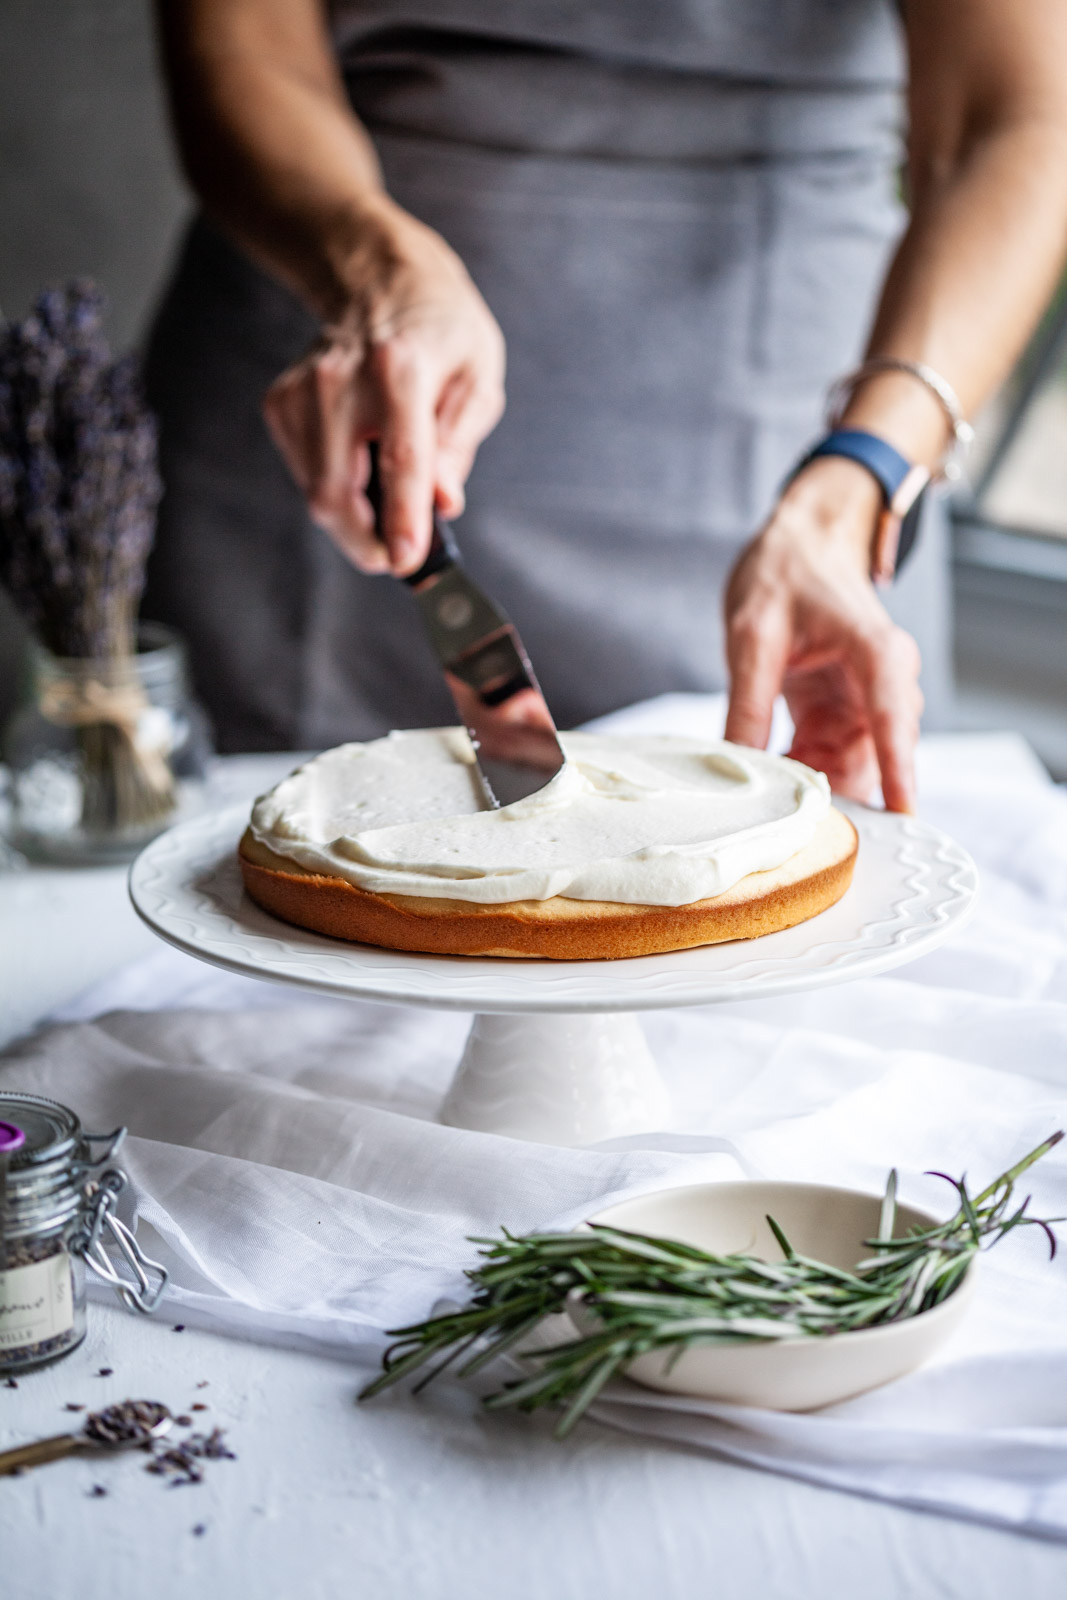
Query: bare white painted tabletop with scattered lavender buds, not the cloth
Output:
[[0, 758, 1067, 1600]]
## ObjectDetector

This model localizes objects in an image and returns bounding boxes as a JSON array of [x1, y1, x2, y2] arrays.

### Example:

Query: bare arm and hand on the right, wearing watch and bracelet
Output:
[[726, 0, 1067, 810]]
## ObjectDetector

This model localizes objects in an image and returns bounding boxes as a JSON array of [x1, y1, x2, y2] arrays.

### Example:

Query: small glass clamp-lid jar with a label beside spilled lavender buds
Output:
[[0, 1093, 166, 1374]]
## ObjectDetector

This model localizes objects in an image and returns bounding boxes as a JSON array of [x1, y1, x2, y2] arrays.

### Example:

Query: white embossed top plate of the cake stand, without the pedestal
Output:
[[130, 798, 977, 1013]]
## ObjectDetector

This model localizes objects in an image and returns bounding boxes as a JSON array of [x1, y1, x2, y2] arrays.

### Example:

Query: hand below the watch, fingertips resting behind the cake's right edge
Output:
[[726, 458, 923, 811]]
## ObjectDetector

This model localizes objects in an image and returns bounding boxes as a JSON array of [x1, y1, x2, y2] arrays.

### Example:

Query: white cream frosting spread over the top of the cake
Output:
[[251, 728, 830, 906]]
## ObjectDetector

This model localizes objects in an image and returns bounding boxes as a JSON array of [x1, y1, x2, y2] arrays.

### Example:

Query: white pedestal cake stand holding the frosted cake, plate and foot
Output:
[[130, 802, 977, 1146]]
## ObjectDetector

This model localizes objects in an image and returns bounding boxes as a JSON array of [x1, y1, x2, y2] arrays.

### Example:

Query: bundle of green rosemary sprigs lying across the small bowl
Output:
[[360, 1131, 1064, 1438]]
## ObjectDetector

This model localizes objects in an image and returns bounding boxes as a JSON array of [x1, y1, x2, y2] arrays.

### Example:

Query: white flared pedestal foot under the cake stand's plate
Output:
[[442, 1013, 670, 1146]]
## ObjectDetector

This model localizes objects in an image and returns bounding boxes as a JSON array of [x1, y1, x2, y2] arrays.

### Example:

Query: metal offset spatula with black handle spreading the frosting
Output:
[[366, 445, 566, 808]]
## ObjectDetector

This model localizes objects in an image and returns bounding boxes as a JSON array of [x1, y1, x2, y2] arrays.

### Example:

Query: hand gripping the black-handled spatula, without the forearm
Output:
[[264, 195, 504, 578]]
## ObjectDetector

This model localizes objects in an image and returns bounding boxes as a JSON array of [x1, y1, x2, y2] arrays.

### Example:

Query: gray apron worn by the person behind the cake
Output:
[[146, 0, 947, 750]]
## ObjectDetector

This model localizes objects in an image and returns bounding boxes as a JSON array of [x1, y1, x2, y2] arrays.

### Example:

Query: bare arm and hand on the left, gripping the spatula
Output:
[[157, 0, 504, 571]]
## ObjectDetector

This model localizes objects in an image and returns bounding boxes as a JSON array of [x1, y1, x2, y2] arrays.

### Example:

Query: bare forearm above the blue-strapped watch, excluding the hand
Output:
[[848, 0, 1067, 462]]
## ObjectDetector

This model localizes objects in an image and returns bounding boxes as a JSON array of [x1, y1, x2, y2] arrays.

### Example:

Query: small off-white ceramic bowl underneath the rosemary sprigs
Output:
[[571, 1182, 974, 1411]]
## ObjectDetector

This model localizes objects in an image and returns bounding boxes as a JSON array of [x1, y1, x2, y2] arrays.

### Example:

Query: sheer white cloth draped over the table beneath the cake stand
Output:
[[0, 702, 1067, 1594]]
